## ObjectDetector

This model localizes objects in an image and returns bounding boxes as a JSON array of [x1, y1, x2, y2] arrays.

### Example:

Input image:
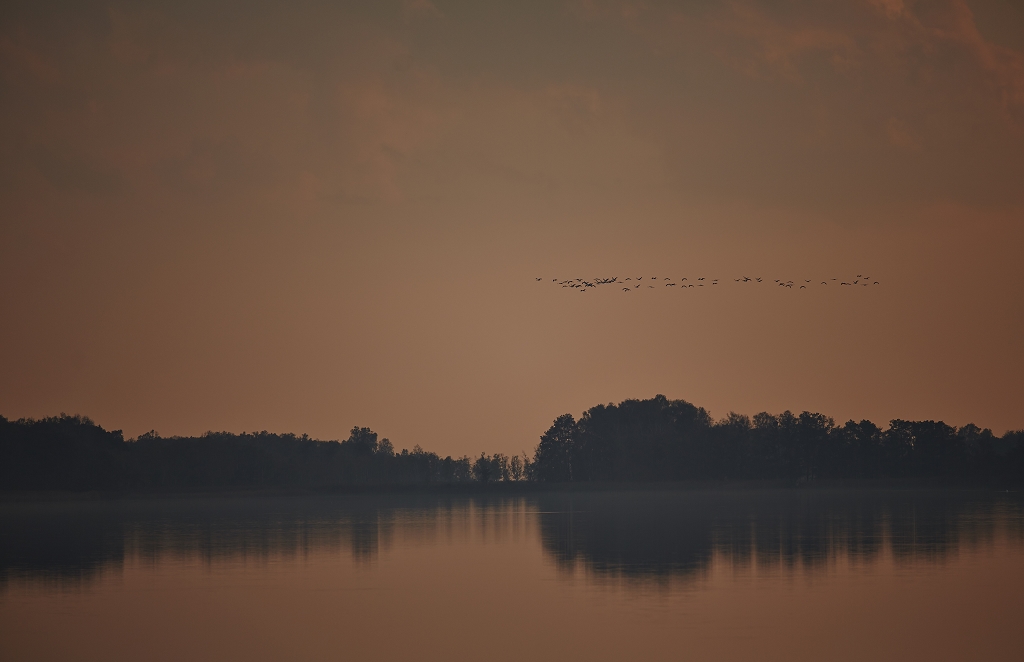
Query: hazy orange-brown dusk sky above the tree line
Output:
[[0, 0, 1024, 456]]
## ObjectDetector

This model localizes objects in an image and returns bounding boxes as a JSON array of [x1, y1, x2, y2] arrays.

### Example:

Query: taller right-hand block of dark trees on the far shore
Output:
[[531, 396, 1024, 483]]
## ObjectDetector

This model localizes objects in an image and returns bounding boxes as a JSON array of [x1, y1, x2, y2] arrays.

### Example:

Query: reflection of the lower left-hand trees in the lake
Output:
[[0, 495, 526, 589]]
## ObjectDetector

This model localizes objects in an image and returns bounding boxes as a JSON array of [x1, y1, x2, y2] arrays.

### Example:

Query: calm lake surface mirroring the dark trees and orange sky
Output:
[[0, 491, 1024, 661]]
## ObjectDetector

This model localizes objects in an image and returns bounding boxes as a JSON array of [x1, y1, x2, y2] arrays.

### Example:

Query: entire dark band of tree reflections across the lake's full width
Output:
[[0, 491, 1024, 590]]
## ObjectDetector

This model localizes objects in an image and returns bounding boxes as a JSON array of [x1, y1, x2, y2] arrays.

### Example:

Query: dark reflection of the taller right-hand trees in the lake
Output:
[[538, 491, 1024, 578]]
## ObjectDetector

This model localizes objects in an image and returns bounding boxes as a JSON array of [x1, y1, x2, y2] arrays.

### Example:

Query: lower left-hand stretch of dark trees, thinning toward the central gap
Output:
[[0, 414, 516, 491]]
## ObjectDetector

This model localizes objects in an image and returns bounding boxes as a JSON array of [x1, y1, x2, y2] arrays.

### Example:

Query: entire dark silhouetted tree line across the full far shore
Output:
[[0, 396, 1024, 491]]
